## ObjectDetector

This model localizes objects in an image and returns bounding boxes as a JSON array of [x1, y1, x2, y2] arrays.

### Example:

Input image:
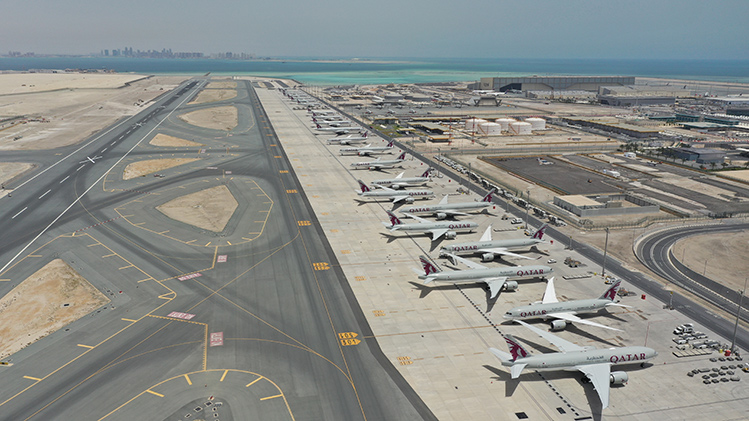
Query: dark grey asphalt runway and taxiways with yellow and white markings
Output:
[[0, 80, 434, 420]]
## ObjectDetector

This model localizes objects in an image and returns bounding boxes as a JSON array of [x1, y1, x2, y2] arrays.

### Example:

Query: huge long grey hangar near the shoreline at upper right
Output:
[[479, 76, 635, 92]]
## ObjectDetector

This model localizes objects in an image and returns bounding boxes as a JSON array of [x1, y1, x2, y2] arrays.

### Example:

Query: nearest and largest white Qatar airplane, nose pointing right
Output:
[[489, 320, 658, 409]]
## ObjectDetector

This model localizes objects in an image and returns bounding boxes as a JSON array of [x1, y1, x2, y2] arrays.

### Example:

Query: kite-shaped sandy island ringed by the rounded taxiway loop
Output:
[[156, 186, 238, 232]]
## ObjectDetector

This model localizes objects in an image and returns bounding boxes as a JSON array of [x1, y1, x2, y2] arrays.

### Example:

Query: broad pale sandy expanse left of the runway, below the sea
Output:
[[0, 73, 185, 150]]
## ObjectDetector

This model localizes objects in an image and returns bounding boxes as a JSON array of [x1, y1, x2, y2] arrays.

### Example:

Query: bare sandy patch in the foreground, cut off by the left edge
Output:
[[0, 259, 109, 358]]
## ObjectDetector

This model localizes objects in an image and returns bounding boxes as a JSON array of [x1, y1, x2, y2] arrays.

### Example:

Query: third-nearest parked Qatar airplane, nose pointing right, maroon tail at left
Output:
[[419, 255, 553, 298]]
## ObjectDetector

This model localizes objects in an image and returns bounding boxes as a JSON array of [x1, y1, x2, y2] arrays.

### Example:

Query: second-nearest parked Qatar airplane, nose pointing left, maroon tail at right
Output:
[[504, 277, 630, 332]]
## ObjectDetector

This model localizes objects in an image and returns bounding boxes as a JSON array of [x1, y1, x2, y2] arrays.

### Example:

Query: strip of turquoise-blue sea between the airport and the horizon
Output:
[[0, 57, 749, 85]]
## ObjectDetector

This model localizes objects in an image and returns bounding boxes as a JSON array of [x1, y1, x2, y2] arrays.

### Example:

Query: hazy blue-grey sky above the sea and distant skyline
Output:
[[0, 0, 749, 59]]
